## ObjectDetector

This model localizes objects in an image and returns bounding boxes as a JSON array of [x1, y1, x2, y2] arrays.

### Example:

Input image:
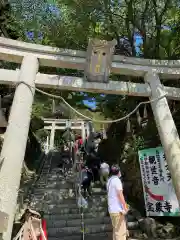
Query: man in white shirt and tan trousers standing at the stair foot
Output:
[[107, 165, 128, 240]]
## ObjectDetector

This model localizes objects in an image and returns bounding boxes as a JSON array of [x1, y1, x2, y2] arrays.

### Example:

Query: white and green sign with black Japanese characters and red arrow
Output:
[[138, 147, 180, 216]]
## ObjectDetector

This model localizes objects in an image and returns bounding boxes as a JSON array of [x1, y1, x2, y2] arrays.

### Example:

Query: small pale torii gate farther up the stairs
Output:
[[43, 118, 91, 150]]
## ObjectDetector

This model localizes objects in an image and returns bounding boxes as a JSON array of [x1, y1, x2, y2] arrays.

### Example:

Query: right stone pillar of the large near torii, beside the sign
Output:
[[145, 72, 180, 204]]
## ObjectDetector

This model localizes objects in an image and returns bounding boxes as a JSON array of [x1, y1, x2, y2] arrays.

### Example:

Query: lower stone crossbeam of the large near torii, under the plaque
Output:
[[0, 69, 180, 101]]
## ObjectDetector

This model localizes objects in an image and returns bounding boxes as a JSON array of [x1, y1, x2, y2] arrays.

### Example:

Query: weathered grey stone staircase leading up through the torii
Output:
[[30, 154, 146, 240]]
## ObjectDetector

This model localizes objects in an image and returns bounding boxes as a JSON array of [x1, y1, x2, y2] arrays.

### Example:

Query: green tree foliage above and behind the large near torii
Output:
[[3, 0, 180, 154]]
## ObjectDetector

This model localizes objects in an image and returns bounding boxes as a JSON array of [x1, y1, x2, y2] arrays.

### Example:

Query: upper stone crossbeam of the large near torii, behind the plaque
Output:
[[0, 37, 180, 79]]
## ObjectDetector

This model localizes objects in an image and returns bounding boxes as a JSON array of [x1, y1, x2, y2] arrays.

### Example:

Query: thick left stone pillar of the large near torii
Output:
[[0, 55, 39, 240]]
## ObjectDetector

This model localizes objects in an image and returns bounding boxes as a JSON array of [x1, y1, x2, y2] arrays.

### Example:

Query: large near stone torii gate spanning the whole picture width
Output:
[[0, 38, 180, 240]]
